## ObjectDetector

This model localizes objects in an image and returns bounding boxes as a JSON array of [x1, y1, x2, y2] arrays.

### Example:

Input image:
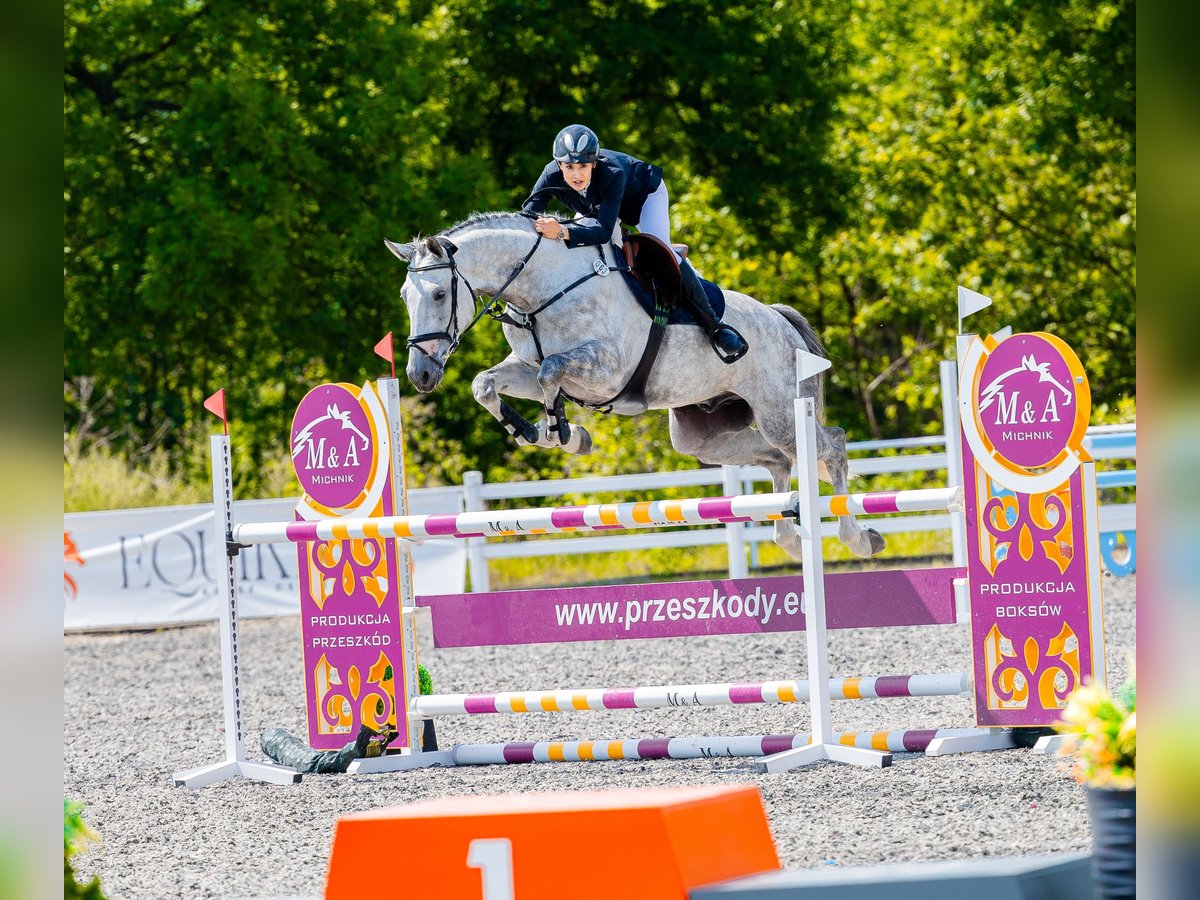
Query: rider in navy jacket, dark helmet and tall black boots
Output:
[[523, 125, 748, 362]]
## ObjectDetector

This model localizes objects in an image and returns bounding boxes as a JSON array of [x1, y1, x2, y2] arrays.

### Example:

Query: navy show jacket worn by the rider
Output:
[[522, 150, 662, 247]]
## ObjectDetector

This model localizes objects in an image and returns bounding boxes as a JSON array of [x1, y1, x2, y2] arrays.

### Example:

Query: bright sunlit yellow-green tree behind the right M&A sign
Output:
[[812, 0, 1135, 436]]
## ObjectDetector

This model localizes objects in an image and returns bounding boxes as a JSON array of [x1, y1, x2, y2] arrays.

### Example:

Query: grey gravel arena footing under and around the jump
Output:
[[64, 574, 1136, 900]]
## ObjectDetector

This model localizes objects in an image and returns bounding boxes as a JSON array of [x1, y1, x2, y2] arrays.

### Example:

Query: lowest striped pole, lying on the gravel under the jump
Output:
[[349, 728, 1012, 774]]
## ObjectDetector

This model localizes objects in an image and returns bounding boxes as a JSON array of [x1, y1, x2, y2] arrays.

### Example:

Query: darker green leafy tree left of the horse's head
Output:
[[65, 0, 504, 487]]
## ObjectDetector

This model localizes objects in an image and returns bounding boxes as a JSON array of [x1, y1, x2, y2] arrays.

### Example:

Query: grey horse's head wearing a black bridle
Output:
[[384, 236, 475, 394]]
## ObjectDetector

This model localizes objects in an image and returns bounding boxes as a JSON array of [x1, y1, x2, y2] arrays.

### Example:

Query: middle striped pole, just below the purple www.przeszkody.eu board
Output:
[[409, 672, 971, 719]]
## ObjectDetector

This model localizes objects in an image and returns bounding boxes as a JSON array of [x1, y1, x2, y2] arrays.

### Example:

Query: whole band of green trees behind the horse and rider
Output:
[[64, 0, 1136, 508]]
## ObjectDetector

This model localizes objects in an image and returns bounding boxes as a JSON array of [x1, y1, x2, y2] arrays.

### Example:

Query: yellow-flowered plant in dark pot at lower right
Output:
[[1056, 676, 1138, 898]]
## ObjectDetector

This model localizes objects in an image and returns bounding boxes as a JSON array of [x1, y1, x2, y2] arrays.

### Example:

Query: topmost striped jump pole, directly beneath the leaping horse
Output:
[[233, 487, 961, 546]]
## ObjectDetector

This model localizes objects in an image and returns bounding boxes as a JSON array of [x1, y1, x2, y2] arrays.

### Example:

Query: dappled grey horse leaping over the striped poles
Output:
[[385, 212, 884, 558]]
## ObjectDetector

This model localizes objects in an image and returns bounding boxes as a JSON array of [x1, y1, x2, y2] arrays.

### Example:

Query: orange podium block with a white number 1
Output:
[[325, 785, 779, 900]]
